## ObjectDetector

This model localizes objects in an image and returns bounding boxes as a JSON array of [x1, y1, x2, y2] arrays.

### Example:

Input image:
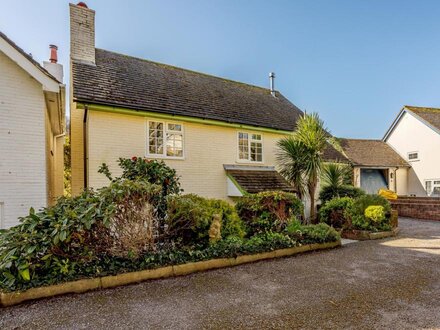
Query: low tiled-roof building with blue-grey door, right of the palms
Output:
[[339, 139, 410, 195]]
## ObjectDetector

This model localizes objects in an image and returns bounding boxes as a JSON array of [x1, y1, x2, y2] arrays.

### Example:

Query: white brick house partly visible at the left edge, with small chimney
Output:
[[0, 32, 65, 229]]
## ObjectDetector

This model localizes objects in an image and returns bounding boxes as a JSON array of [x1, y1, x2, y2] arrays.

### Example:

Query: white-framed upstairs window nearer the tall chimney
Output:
[[147, 121, 183, 158]]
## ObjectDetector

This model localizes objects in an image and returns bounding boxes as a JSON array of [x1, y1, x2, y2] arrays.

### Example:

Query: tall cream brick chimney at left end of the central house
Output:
[[69, 2, 95, 64]]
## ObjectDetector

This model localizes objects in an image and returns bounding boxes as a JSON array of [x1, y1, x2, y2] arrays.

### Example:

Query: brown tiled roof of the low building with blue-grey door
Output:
[[339, 139, 409, 167]]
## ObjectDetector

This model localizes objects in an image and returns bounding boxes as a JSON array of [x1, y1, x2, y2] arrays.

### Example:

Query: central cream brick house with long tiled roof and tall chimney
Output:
[[70, 3, 345, 200]]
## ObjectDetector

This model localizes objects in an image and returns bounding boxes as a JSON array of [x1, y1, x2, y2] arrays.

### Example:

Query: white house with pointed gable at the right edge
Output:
[[383, 106, 440, 197]]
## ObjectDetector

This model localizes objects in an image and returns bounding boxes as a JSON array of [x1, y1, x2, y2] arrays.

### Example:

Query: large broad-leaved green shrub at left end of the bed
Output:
[[0, 180, 160, 290]]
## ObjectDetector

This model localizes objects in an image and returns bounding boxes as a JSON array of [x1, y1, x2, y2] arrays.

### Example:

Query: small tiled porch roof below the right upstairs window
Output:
[[226, 169, 295, 194]]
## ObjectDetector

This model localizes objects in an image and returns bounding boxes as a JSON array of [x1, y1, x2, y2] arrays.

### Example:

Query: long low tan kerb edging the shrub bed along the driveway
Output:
[[0, 239, 341, 307]]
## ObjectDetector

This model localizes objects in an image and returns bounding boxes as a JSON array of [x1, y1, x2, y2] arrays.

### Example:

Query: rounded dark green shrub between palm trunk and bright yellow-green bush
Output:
[[319, 197, 353, 228]]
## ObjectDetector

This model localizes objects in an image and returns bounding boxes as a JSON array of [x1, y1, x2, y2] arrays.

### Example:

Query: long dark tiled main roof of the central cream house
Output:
[[72, 49, 302, 131]]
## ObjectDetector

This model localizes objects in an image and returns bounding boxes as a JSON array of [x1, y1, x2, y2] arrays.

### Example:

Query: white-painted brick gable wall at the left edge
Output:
[[0, 52, 47, 228]]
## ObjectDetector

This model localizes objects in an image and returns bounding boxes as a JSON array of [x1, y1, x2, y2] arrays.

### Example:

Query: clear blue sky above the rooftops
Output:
[[0, 0, 440, 138]]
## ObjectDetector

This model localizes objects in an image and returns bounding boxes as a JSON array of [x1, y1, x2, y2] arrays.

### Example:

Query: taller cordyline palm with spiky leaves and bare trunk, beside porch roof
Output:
[[277, 113, 330, 222]]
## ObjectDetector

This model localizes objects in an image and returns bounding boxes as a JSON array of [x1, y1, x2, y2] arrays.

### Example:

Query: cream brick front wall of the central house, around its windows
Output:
[[81, 111, 285, 199]]
